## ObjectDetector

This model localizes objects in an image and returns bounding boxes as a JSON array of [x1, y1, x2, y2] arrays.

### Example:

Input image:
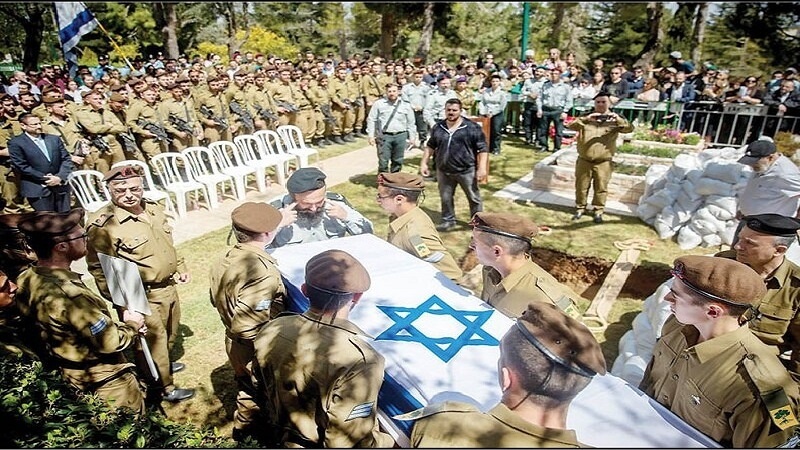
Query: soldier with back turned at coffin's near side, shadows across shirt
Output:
[[253, 250, 394, 448]]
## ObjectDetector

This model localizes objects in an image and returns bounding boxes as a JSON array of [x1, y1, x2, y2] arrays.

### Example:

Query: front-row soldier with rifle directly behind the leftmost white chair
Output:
[[75, 91, 128, 172]]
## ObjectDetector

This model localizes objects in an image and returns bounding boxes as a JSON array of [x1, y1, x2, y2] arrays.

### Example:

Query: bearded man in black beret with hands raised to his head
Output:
[[270, 167, 372, 248]]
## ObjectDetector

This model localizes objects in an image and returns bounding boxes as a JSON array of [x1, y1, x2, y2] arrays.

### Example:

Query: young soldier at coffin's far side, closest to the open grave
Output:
[[470, 212, 581, 319]]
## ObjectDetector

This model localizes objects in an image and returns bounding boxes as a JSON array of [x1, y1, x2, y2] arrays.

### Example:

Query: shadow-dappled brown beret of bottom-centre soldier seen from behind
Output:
[[504, 302, 606, 378]]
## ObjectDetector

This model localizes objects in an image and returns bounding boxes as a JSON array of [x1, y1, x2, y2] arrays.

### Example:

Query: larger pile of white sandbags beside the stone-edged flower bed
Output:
[[636, 147, 753, 250]]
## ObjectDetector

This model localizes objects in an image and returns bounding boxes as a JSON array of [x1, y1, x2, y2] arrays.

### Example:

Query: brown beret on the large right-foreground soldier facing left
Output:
[[671, 255, 767, 306]]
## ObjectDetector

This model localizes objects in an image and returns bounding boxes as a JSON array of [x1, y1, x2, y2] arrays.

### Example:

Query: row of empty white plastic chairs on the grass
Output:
[[68, 125, 319, 217]]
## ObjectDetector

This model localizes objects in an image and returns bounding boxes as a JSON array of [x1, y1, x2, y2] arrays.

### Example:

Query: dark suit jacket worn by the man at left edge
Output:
[[8, 133, 73, 198]]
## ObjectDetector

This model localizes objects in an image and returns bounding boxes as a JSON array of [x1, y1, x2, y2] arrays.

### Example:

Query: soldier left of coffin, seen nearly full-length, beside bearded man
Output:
[[210, 202, 286, 440]]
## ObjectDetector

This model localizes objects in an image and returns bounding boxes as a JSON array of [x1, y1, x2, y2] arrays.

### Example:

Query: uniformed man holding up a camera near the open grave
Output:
[[567, 91, 633, 223]]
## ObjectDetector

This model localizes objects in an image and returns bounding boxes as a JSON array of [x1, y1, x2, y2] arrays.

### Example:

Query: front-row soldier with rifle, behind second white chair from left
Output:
[[126, 87, 169, 162]]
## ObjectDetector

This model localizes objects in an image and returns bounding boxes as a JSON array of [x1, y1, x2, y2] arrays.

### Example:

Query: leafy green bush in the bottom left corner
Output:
[[0, 357, 234, 448]]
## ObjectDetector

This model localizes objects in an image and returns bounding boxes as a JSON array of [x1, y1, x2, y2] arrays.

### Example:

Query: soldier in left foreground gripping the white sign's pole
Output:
[[17, 208, 144, 413]]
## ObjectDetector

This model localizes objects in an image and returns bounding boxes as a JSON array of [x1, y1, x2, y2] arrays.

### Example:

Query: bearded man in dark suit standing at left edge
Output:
[[8, 114, 72, 212]]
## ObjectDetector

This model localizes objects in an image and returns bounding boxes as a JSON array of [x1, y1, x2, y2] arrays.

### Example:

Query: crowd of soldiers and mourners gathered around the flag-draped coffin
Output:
[[0, 44, 800, 447]]
